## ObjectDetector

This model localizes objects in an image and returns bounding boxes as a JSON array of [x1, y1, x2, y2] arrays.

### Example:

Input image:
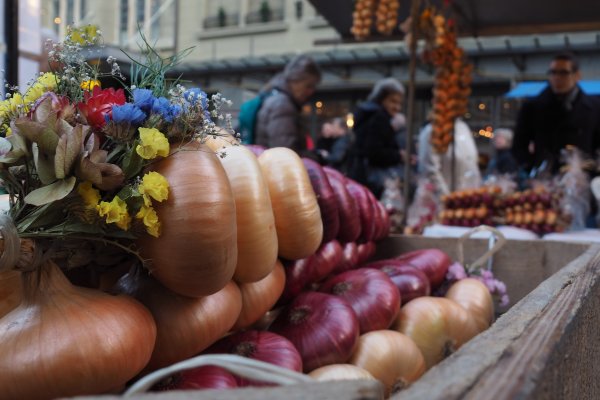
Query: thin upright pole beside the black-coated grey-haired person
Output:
[[402, 0, 421, 226]]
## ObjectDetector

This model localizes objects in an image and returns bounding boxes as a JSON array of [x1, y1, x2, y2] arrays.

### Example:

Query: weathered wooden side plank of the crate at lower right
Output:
[[392, 245, 600, 400]]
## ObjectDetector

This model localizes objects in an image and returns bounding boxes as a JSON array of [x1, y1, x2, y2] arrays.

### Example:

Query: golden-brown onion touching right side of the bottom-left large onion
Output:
[[117, 270, 242, 371]]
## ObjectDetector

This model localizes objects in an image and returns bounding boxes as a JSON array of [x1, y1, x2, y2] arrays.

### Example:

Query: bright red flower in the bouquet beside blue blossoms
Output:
[[77, 86, 125, 130]]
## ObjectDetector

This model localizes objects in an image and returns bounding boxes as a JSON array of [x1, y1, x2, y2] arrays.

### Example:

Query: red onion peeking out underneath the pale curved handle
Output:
[[152, 365, 238, 391]]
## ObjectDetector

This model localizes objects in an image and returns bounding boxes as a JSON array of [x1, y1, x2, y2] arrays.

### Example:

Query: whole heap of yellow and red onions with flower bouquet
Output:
[[0, 26, 507, 399]]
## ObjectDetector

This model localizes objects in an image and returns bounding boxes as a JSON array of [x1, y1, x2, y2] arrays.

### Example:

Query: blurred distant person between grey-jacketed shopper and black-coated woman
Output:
[[316, 118, 352, 173]]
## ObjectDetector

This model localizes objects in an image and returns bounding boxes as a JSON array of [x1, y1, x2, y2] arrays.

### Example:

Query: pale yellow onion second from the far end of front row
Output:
[[392, 296, 478, 369]]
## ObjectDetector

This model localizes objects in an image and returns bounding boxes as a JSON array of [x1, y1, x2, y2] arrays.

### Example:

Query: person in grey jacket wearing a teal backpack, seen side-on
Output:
[[255, 55, 321, 158]]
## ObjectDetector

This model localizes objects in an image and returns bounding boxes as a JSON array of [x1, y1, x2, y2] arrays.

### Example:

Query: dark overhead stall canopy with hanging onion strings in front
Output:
[[309, 0, 600, 40]]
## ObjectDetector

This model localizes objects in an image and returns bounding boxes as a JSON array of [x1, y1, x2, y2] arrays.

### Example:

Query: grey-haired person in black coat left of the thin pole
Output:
[[349, 78, 404, 198]]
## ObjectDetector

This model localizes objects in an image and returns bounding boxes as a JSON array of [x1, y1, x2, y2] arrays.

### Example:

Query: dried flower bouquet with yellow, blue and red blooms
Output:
[[0, 27, 237, 278]]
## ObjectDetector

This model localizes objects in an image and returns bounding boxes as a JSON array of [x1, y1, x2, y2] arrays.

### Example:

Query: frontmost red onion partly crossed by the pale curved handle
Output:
[[204, 330, 302, 386]]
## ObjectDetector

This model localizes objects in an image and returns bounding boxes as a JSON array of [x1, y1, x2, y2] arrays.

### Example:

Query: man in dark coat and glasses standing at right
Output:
[[512, 53, 600, 173]]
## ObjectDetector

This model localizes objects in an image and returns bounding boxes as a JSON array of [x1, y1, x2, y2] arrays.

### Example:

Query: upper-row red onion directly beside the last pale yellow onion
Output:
[[323, 167, 361, 243]]
